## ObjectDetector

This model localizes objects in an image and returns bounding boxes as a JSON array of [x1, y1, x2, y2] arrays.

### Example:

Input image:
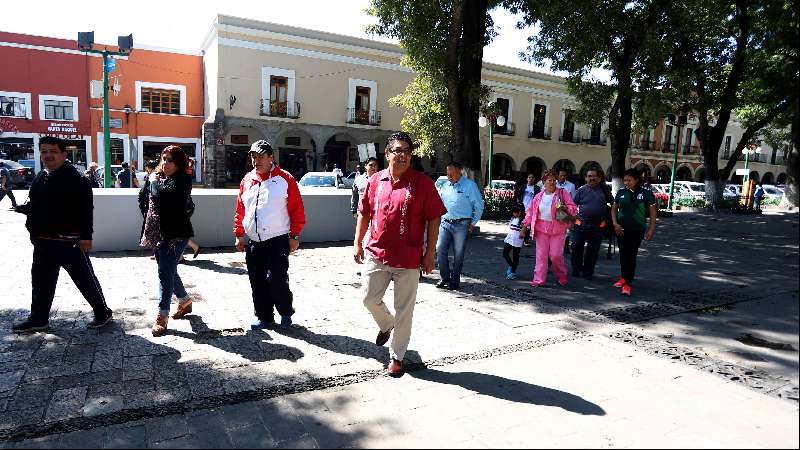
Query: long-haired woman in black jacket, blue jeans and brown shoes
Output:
[[140, 145, 194, 336]]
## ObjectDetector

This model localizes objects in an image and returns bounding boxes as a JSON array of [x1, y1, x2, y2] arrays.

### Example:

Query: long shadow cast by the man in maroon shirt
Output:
[[408, 369, 606, 416]]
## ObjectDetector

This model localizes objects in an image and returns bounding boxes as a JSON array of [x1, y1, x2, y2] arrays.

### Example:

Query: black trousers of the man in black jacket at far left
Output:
[[30, 238, 111, 324]]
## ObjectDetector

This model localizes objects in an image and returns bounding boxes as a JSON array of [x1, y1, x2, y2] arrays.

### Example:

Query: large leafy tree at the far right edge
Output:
[[666, 0, 800, 205]]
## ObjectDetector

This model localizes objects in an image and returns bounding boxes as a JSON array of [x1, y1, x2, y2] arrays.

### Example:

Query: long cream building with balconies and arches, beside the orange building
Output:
[[203, 15, 610, 186]]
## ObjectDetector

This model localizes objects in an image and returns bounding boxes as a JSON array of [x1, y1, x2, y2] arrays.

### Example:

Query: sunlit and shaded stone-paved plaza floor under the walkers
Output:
[[0, 192, 799, 448]]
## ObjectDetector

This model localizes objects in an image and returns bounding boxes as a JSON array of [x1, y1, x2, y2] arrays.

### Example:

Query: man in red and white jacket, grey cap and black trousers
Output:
[[233, 140, 306, 330]]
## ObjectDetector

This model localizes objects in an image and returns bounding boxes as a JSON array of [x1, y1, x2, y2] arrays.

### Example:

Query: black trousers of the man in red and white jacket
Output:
[[245, 234, 294, 322]]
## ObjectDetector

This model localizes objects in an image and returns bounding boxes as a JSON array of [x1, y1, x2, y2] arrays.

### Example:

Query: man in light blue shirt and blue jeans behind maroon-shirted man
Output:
[[436, 161, 483, 290]]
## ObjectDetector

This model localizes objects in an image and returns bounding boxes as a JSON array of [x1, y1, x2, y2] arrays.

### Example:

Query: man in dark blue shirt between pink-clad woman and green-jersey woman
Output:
[[572, 170, 614, 280]]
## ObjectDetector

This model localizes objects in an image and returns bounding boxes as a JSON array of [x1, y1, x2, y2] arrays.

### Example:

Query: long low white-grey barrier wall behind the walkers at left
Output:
[[93, 188, 355, 251]]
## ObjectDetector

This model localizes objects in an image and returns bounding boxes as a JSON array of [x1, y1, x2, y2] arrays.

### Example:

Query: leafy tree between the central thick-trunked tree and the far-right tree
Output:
[[504, 0, 670, 189]]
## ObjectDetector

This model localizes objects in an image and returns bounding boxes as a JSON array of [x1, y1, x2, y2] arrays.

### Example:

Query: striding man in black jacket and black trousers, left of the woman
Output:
[[11, 136, 112, 333]]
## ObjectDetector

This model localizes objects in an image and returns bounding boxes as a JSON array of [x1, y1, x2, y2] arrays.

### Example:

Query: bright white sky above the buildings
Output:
[[0, 0, 550, 73]]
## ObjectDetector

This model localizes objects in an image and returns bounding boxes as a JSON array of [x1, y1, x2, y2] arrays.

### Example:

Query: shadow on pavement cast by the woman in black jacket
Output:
[[167, 314, 304, 362]]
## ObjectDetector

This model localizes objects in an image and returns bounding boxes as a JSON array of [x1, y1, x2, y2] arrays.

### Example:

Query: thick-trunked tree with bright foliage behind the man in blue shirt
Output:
[[367, 0, 497, 173]]
